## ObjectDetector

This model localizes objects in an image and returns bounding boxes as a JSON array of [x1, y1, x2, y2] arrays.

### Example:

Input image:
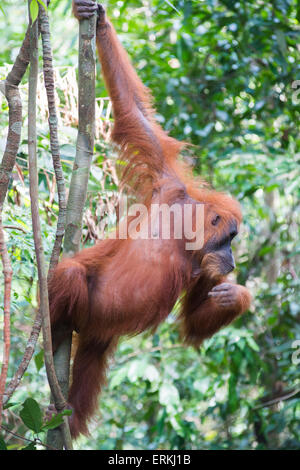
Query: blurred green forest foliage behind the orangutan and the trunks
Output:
[[0, 0, 300, 449]]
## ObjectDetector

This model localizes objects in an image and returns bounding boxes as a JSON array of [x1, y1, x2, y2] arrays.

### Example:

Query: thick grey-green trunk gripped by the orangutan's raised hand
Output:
[[47, 4, 96, 449]]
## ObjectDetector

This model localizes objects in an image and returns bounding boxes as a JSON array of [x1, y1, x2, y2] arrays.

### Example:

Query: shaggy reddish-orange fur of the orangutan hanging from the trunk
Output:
[[49, 2, 250, 437]]
